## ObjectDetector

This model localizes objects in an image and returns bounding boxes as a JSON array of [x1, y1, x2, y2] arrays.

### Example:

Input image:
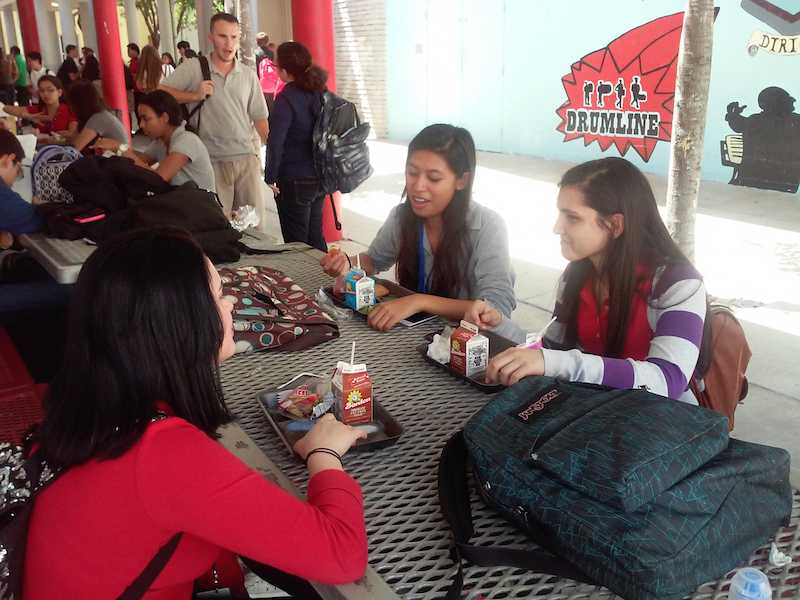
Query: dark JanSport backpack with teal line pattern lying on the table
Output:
[[439, 377, 792, 600]]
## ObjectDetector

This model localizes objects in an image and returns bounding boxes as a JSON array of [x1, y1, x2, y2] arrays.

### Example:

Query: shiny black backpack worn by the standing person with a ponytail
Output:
[[312, 91, 372, 229]]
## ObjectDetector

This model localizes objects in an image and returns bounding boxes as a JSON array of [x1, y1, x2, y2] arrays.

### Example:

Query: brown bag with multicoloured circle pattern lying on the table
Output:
[[219, 267, 339, 354]]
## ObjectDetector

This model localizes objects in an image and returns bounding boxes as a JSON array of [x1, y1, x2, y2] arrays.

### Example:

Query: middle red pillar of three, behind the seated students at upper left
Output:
[[95, 0, 131, 136]]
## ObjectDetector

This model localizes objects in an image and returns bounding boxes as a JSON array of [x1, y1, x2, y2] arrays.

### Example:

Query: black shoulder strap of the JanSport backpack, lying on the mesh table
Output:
[[439, 431, 595, 600]]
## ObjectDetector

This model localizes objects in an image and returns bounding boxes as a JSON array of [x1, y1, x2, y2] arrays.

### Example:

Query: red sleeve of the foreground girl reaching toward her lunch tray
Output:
[[136, 418, 367, 584]]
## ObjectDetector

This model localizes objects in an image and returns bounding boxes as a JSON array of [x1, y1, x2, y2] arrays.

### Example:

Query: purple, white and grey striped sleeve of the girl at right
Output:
[[542, 265, 706, 400]]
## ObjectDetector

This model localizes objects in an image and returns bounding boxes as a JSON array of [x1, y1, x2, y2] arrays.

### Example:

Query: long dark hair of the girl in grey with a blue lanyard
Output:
[[397, 123, 475, 298]]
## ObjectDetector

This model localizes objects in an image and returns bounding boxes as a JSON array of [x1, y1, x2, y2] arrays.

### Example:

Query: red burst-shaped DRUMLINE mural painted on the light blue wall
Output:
[[556, 12, 683, 161]]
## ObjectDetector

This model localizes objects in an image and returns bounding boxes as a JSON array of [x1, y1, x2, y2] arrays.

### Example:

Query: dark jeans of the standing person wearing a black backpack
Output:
[[275, 177, 328, 252]]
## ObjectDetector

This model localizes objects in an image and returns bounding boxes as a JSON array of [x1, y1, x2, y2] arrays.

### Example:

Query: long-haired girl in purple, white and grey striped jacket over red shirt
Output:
[[465, 158, 706, 404]]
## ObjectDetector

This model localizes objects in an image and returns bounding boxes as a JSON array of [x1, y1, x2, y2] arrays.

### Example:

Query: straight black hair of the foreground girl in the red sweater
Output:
[[40, 228, 231, 467]]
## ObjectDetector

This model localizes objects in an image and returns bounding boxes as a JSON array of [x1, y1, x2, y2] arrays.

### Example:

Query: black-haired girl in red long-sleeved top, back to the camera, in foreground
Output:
[[23, 228, 367, 600]]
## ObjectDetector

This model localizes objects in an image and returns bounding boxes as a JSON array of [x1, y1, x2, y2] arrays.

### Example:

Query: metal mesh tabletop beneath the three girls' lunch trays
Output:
[[221, 250, 800, 600]]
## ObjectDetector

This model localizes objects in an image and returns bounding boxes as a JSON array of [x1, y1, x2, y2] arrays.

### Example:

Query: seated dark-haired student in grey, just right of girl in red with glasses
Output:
[[67, 81, 130, 151]]
